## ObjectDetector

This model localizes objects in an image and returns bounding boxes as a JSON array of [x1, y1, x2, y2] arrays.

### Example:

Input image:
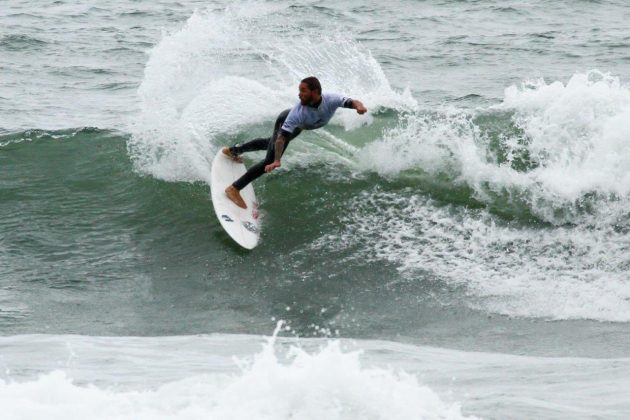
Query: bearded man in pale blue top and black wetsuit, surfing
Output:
[[223, 77, 367, 209]]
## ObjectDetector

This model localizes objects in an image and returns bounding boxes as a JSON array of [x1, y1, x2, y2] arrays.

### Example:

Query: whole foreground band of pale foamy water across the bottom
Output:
[[0, 334, 630, 420]]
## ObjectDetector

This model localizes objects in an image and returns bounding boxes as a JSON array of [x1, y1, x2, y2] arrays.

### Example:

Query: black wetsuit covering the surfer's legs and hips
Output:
[[230, 109, 302, 191]]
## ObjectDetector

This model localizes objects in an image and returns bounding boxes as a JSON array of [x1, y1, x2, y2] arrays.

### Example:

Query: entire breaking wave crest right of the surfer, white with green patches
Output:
[[359, 70, 630, 226]]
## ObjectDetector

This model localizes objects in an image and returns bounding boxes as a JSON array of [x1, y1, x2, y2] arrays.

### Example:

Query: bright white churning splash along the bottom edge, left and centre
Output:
[[0, 328, 474, 420]]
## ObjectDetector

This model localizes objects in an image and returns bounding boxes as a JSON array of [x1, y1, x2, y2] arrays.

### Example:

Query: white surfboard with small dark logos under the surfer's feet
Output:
[[210, 149, 260, 249]]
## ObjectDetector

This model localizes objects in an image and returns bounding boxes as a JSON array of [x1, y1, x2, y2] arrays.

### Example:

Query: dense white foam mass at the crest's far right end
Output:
[[499, 70, 630, 200]]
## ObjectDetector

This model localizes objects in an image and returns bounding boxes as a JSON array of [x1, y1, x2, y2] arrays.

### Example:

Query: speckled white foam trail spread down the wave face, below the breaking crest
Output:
[[313, 190, 630, 322]]
